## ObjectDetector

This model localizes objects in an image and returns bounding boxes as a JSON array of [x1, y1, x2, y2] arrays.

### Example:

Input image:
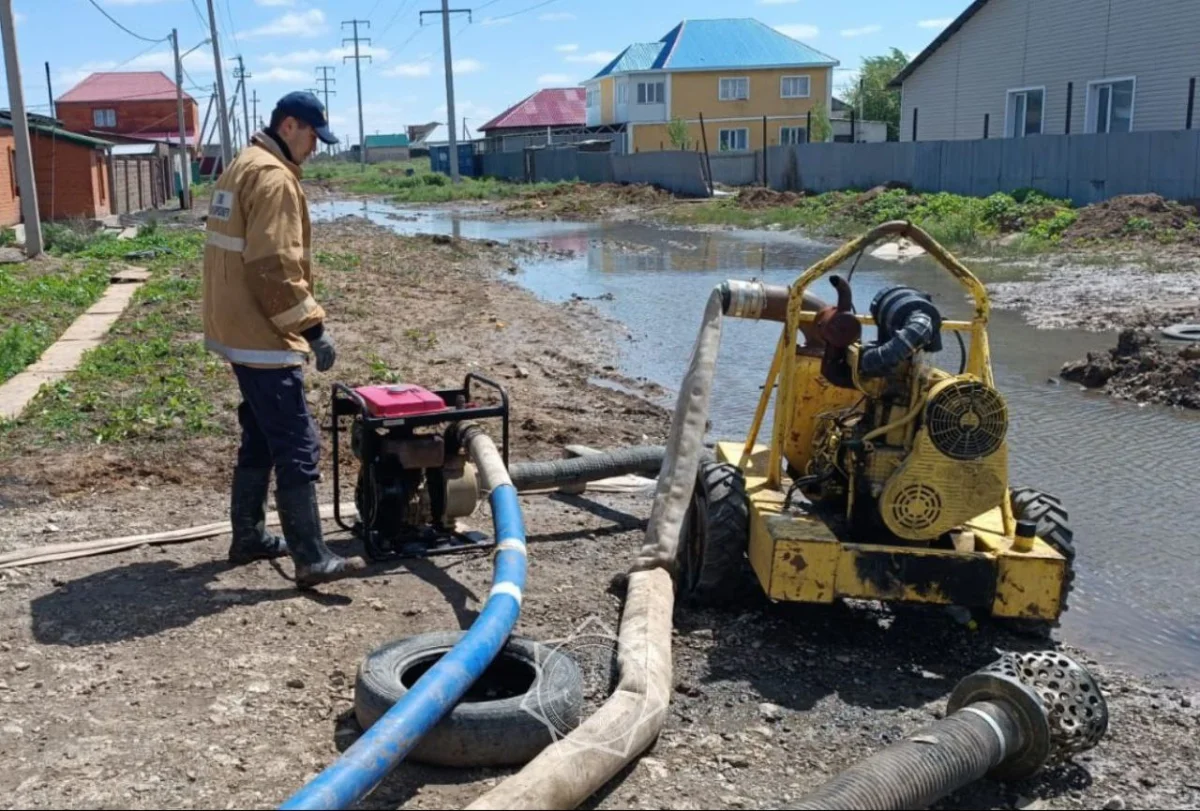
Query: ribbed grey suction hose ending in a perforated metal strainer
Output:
[[790, 651, 1109, 810]]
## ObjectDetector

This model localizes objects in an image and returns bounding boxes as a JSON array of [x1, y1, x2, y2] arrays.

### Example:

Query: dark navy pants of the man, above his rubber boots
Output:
[[233, 364, 320, 489]]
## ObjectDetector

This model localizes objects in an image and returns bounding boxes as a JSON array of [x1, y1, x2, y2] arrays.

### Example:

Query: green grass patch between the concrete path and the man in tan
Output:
[[0, 229, 220, 444]]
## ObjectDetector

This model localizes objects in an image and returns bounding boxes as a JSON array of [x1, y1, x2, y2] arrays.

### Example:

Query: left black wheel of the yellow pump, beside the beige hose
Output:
[[677, 462, 750, 606]]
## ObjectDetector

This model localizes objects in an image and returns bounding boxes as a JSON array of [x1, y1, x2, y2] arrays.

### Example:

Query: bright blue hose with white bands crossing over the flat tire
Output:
[[280, 468, 526, 809]]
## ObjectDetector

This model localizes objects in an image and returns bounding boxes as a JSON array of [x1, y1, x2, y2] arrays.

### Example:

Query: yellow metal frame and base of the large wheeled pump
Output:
[[718, 221, 1067, 620]]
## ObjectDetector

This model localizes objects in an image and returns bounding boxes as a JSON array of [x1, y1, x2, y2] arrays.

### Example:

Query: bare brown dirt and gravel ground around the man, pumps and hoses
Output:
[[0, 212, 1200, 809]]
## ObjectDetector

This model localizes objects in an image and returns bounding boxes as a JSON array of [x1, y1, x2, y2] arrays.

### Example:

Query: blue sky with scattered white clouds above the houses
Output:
[[0, 0, 968, 144]]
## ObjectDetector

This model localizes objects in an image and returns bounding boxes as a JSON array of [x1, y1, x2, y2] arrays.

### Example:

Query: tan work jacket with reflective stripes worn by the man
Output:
[[204, 132, 325, 367]]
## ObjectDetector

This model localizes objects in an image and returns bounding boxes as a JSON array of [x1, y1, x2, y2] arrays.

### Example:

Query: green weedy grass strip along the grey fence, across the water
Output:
[[673, 188, 1078, 253]]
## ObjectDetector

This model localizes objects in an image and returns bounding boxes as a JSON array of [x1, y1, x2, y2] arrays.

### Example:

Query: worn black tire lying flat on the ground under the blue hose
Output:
[[354, 631, 583, 768]]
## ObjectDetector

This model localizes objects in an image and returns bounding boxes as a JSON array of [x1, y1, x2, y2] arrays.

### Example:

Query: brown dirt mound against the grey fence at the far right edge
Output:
[[1064, 194, 1200, 245]]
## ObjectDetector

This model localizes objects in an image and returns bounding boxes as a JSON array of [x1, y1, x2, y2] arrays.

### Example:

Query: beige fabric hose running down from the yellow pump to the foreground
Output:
[[467, 290, 721, 809]]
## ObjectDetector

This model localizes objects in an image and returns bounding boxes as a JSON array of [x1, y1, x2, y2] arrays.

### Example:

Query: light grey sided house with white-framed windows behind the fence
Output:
[[892, 0, 1200, 140]]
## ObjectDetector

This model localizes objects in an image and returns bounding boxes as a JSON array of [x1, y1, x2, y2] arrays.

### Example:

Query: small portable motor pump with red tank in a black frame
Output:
[[331, 372, 509, 560]]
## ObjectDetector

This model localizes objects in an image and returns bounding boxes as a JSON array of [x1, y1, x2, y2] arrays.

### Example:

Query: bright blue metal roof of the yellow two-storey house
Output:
[[592, 18, 838, 79]]
